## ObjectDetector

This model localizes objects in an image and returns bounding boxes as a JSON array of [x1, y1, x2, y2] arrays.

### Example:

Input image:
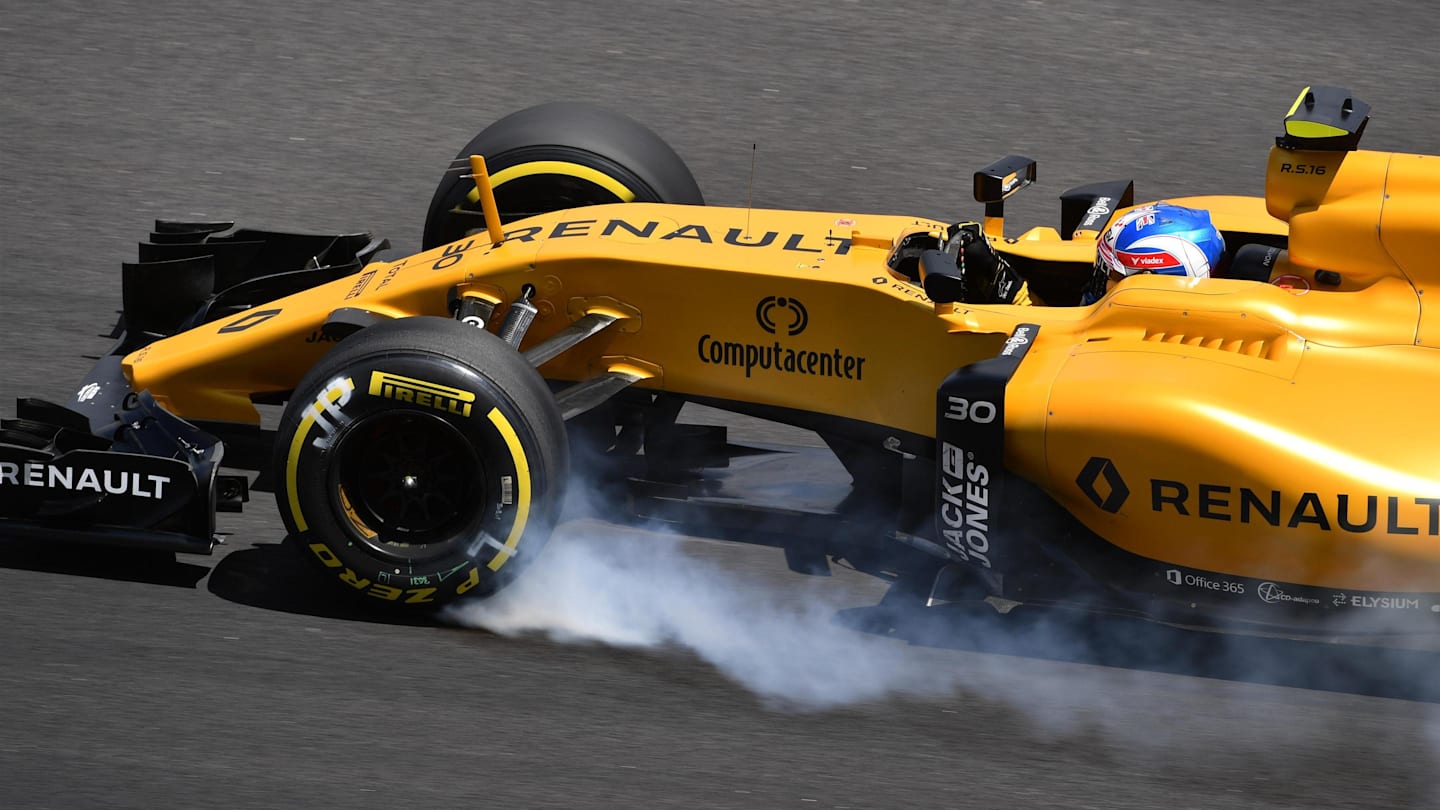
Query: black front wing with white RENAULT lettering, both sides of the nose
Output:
[[0, 221, 389, 553]]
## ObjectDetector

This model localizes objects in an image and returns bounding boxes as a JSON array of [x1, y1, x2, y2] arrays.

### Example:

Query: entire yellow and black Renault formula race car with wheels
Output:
[[0, 86, 1440, 631]]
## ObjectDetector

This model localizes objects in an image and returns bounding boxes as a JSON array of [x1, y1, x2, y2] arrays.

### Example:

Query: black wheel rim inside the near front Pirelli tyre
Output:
[[331, 411, 490, 561]]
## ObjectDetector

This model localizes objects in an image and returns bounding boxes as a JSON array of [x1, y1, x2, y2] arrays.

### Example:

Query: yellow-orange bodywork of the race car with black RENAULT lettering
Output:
[[124, 140, 1440, 591]]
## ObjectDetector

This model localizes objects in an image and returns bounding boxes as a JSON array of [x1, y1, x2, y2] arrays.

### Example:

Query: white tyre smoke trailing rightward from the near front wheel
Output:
[[448, 507, 1290, 749]]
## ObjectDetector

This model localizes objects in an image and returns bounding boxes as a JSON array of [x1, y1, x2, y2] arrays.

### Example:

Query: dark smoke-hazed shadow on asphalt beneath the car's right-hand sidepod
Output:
[[835, 604, 1440, 703]]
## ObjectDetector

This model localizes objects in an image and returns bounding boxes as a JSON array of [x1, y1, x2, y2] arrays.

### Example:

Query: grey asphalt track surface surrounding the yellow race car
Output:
[[0, 0, 1440, 809]]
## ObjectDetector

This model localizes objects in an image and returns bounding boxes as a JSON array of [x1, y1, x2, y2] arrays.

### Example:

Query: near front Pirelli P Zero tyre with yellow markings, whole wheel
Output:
[[275, 317, 569, 608]]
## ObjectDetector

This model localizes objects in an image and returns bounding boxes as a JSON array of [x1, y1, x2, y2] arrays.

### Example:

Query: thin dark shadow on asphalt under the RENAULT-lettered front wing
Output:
[[0, 539, 210, 588]]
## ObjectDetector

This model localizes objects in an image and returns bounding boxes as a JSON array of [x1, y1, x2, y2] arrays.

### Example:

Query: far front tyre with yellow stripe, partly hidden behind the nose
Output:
[[423, 101, 706, 249]]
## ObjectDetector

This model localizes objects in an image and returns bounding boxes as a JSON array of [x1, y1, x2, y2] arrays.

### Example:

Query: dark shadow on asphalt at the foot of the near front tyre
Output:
[[207, 543, 448, 627]]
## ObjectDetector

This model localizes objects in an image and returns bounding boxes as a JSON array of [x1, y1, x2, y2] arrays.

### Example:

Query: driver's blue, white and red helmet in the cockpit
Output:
[[1080, 203, 1225, 304]]
